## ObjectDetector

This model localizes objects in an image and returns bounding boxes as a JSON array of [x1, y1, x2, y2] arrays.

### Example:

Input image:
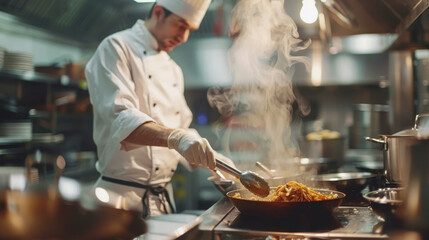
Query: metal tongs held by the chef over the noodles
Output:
[[216, 159, 270, 197]]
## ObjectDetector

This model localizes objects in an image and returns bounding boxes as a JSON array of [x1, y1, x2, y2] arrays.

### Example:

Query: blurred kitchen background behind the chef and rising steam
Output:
[[0, 0, 429, 213]]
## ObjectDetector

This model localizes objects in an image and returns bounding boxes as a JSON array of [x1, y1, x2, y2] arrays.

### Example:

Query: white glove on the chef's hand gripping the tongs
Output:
[[167, 129, 216, 170]]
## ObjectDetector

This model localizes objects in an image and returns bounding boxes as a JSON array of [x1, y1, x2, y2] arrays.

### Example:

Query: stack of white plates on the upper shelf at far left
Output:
[[3, 52, 34, 71]]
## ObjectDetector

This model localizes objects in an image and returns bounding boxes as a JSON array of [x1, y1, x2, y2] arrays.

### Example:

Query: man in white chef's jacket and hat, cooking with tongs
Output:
[[85, 0, 232, 218]]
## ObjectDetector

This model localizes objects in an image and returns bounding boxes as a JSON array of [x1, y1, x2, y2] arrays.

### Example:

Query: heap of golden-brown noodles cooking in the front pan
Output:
[[234, 181, 338, 202]]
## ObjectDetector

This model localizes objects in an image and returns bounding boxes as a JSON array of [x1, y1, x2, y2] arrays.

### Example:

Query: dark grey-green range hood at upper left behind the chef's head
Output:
[[0, 0, 221, 46]]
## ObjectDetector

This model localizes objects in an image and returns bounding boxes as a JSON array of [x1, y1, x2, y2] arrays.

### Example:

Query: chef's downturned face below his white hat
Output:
[[155, 7, 196, 52]]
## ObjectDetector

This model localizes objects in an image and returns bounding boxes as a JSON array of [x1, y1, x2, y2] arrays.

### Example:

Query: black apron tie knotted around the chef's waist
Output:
[[101, 176, 176, 218]]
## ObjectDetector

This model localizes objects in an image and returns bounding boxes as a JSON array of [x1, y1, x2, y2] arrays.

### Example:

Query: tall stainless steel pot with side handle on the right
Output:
[[365, 114, 429, 184]]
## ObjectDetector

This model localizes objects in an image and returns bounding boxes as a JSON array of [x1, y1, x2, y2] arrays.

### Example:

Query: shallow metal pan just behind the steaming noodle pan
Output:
[[310, 172, 377, 194]]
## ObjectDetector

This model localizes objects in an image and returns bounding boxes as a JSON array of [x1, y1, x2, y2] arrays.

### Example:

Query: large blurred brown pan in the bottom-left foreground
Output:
[[0, 190, 147, 240]]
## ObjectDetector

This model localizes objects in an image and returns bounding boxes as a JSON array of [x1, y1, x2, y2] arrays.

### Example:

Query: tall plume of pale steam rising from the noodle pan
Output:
[[208, 0, 310, 170]]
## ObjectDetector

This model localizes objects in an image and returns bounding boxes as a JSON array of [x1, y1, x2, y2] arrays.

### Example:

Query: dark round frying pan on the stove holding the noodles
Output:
[[226, 188, 346, 218]]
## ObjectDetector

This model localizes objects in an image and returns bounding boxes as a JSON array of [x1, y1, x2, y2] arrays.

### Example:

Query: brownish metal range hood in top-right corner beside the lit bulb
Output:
[[319, 0, 429, 51]]
